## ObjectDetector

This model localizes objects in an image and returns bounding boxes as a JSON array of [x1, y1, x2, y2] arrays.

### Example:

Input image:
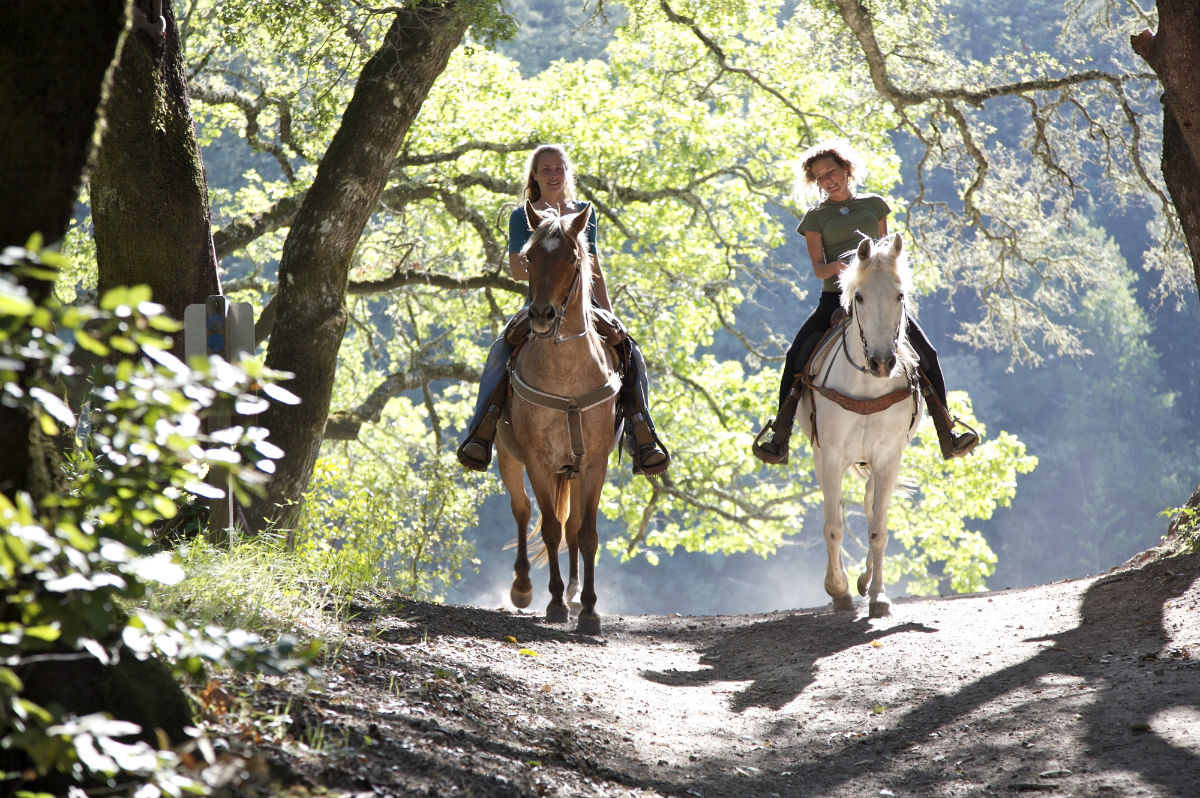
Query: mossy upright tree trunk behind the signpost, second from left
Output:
[[91, 0, 221, 340]]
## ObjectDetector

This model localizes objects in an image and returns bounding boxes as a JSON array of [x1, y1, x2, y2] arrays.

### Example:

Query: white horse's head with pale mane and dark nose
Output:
[[840, 234, 912, 377]]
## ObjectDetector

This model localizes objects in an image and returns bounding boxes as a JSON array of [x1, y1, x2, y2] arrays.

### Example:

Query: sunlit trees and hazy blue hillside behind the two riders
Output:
[[59, 0, 1200, 613]]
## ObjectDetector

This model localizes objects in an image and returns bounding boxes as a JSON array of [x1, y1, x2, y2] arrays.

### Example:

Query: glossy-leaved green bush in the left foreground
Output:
[[0, 241, 313, 792]]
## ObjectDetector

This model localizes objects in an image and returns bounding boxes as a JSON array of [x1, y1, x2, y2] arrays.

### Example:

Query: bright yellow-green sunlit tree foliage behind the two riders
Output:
[[159, 2, 1041, 581]]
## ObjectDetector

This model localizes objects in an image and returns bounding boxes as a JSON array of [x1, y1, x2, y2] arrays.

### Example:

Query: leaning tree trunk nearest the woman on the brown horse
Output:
[[247, 0, 468, 529]]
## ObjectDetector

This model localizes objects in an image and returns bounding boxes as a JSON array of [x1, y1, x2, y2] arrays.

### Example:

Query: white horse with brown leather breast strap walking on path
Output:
[[800, 235, 924, 618]]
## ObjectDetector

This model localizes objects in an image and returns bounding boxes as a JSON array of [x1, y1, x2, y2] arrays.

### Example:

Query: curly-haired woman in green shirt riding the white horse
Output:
[[754, 144, 979, 463]]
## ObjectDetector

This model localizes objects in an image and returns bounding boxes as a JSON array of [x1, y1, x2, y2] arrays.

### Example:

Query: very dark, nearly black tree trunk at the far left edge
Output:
[[0, 0, 127, 496]]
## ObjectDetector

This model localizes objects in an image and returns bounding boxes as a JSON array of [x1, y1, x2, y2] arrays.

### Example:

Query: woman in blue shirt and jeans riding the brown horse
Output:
[[458, 144, 671, 474]]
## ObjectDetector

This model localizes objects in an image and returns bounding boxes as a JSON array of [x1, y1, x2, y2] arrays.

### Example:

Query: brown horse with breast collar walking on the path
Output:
[[497, 202, 620, 635]]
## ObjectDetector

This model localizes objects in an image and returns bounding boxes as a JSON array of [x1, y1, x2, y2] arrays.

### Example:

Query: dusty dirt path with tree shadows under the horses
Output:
[[211, 544, 1200, 798]]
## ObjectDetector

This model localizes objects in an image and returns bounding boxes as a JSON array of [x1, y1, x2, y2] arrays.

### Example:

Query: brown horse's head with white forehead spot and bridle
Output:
[[524, 200, 592, 337]]
